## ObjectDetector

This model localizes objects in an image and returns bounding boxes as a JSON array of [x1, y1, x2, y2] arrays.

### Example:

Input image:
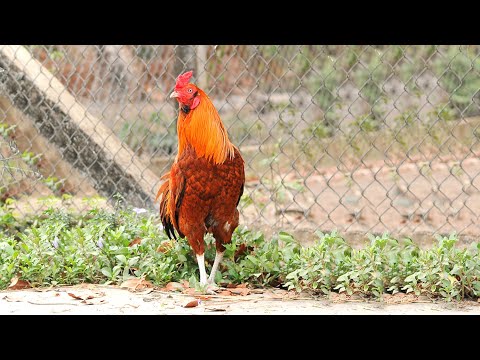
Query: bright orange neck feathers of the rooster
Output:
[[177, 89, 234, 164]]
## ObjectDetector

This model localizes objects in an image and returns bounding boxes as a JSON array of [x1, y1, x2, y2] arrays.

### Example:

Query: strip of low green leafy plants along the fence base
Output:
[[0, 200, 480, 301]]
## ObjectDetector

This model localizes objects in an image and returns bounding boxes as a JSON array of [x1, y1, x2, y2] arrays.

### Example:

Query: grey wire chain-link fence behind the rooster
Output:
[[0, 45, 480, 236]]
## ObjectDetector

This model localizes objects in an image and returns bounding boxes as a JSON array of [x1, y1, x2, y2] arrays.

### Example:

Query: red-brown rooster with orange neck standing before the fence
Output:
[[156, 71, 245, 289]]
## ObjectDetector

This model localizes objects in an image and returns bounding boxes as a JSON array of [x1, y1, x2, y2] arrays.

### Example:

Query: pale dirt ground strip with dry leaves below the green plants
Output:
[[0, 284, 480, 315]]
